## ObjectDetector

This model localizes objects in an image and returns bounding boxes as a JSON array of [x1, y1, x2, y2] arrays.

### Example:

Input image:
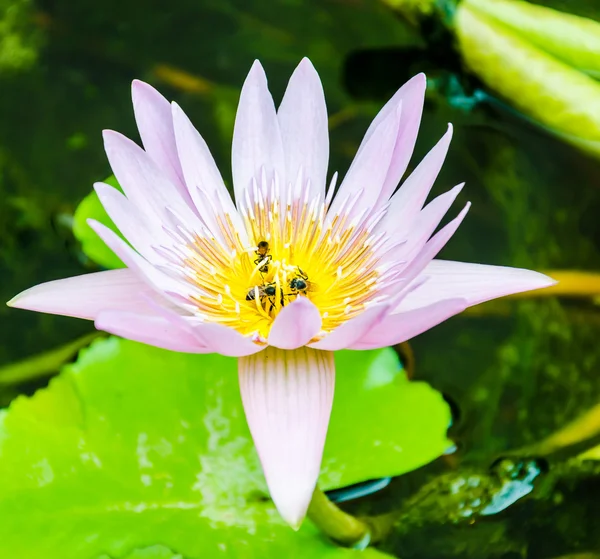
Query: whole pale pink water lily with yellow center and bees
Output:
[[9, 59, 553, 527]]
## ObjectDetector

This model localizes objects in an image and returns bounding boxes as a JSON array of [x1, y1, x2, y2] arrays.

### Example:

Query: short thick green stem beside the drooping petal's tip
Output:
[[308, 487, 393, 549]]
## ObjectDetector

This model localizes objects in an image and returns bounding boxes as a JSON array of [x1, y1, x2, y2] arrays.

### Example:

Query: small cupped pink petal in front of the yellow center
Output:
[[269, 297, 321, 349]]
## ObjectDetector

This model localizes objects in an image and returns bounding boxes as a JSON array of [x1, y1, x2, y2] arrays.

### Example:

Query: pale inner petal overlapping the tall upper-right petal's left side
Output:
[[328, 103, 401, 218]]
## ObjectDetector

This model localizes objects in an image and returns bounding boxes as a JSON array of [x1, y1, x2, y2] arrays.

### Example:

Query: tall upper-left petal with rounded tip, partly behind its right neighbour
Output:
[[131, 80, 189, 199]]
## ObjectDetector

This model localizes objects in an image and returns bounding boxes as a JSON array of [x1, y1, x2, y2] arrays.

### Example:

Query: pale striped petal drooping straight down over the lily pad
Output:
[[239, 347, 335, 528]]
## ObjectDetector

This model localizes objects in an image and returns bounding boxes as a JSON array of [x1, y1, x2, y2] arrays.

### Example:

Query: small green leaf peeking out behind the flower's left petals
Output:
[[73, 176, 125, 268]]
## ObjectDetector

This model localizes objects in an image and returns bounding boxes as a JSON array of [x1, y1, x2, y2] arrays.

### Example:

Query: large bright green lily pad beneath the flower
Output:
[[0, 338, 450, 559]]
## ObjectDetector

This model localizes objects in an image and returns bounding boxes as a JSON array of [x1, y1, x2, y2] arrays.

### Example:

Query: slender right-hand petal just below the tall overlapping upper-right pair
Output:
[[380, 124, 452, 241]]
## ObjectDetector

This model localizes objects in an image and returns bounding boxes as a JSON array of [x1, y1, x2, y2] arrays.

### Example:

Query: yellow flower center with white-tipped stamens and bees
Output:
[[176, 177, 381, 339]]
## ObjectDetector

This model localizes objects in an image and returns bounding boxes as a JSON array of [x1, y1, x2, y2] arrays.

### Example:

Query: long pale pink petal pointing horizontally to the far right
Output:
[[395, 260, 556, 312]]
